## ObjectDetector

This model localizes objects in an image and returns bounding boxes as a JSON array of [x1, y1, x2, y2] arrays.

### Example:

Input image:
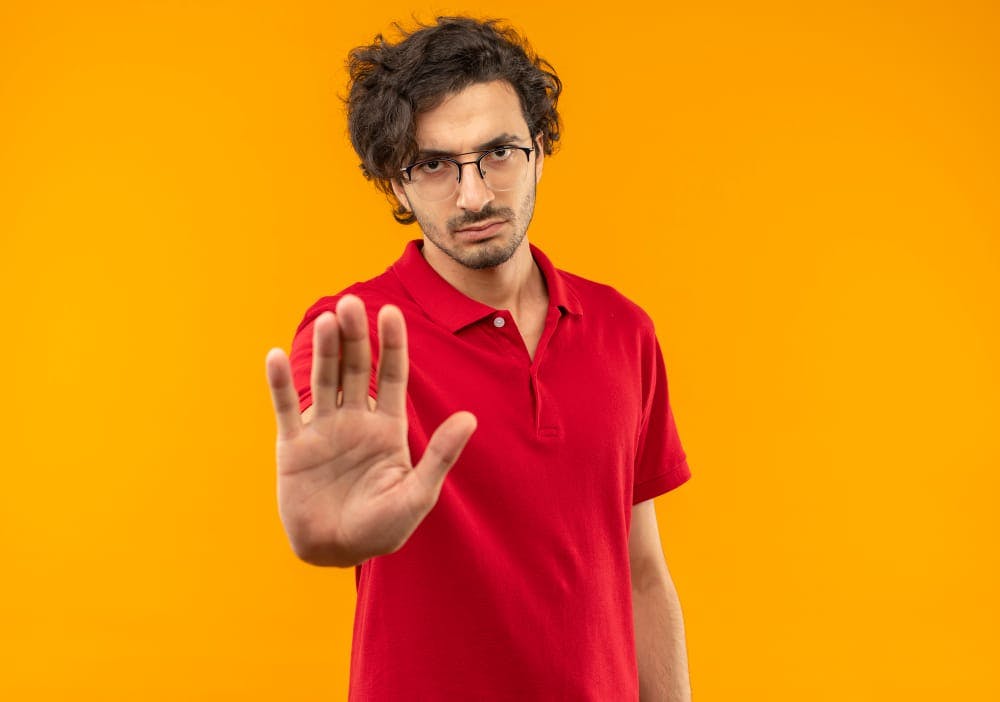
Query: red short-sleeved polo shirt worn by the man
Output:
[[291, 241, 690, 702]]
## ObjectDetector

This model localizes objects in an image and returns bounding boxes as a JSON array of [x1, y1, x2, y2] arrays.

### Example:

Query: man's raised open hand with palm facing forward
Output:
[[267, 295, 476, 566]]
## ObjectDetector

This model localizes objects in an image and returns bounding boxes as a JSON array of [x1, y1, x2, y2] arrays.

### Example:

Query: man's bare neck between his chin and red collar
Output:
[[422, 237, 548, 316]]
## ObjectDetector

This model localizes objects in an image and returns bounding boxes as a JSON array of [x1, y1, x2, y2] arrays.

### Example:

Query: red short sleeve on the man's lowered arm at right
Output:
[[632, 336, 691, 504]]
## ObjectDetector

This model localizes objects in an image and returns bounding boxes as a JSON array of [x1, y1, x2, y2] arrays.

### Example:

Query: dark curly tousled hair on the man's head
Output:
[[346, 17, 562, 224]]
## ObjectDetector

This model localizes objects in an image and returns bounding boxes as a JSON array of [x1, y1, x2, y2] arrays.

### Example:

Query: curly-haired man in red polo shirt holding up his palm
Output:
[[267, 18, 690, 702]]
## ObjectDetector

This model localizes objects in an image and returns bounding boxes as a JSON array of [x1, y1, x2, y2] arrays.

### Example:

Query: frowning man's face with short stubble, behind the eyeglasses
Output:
[[393, 81, 542, 269]]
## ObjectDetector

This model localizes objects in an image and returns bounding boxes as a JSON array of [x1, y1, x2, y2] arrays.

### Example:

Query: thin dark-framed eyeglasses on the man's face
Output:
[[399, 144, 535, 202]]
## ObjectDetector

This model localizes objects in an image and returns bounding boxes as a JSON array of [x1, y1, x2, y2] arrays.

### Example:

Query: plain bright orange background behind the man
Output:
[[0, 0, 1000, 702]]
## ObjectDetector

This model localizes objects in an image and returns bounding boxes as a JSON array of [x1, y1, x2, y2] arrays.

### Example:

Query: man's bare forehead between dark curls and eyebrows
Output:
[[416, 81, 531, 154]]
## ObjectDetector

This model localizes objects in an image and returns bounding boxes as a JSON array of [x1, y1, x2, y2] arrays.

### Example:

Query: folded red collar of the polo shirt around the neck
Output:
[[391, 239, 583, 333]]
